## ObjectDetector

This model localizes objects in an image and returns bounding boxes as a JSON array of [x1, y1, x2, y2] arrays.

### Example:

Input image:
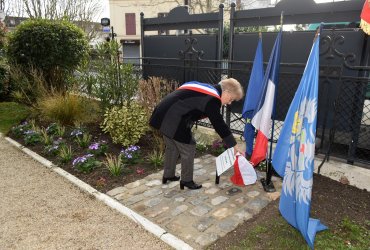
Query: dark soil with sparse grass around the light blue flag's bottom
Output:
[[209, 174, 370, 250]]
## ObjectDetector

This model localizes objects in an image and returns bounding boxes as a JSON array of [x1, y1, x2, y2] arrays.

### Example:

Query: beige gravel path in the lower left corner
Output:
[[0, 137, 169, 250]]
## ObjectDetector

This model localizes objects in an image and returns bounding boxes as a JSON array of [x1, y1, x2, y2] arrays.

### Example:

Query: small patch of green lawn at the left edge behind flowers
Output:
[[0, 102, 30, 134]]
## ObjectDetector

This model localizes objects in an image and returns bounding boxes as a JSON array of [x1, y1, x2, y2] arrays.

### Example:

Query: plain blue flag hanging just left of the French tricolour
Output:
[[242, 37, 264, 155]]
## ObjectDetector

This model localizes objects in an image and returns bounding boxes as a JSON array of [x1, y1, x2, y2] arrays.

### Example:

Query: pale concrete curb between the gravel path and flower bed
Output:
[[0, 136, 193, 250]]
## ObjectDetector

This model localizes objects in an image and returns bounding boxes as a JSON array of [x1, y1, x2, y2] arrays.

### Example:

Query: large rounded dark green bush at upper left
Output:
[[7, 19, 88, 91]]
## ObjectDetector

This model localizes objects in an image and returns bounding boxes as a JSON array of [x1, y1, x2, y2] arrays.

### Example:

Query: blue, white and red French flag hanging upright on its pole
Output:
[[250, 30, 282, 166]]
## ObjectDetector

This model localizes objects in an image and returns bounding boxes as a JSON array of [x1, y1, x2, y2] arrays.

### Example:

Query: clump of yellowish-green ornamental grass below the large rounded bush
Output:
[[38, 93, 99, 125]]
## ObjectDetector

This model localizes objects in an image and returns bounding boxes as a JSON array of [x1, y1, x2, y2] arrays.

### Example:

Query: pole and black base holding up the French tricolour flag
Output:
[[261, 11, 284, 192]]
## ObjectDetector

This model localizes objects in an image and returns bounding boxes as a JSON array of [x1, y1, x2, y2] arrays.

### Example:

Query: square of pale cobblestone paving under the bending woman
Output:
[[107, 155, 281, 249]]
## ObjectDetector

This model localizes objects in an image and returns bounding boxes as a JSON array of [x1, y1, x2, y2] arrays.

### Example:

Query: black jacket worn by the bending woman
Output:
[[149, 85, 236, 147]]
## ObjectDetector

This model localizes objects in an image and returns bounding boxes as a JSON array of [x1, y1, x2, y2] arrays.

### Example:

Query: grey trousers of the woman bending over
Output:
[[163, 136, 195, 181]]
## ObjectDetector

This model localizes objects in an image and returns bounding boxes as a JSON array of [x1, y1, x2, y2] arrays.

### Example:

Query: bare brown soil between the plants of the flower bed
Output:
[[8, 122, 209, 192]]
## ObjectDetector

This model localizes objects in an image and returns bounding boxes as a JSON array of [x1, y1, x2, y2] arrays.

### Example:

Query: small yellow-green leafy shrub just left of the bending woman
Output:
[[101, 102, 149, 147]]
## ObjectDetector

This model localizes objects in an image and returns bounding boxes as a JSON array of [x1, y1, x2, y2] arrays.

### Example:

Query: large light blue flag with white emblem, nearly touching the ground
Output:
[[272, 29, 327, 249]]
